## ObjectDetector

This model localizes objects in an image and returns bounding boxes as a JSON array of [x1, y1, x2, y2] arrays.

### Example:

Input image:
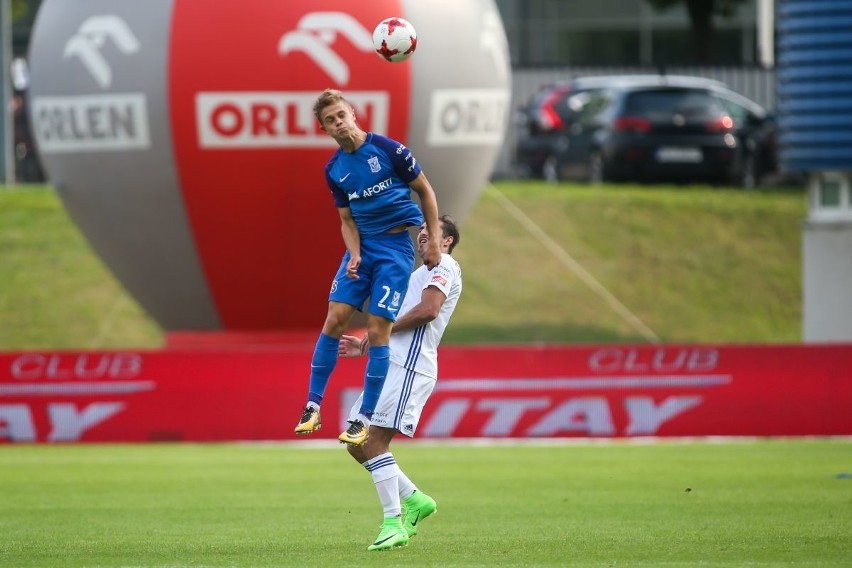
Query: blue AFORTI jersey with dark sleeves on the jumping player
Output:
[[325, 132, 423, 237]]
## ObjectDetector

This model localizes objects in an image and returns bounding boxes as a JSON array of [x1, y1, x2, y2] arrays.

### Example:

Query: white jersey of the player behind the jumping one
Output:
[[390, 254, 462, 378]]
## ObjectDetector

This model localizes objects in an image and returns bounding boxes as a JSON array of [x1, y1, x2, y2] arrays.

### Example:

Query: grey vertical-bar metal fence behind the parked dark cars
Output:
[[493, 66, 776, 177]]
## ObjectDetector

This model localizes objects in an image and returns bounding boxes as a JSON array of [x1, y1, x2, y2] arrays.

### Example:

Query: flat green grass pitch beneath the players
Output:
[[0, 439, 852, 568]]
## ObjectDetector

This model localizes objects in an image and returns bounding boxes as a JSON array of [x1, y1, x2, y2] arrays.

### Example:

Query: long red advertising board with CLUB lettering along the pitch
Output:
[[0, 345, 852, 442]]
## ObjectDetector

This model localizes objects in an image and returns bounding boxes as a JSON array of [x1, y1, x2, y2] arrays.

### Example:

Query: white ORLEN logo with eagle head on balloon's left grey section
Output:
[[33, 15, 150, 154]]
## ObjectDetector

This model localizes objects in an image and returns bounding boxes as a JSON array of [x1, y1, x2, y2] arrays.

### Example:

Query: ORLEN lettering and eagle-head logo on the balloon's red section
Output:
[[195, 12, 390, 148]]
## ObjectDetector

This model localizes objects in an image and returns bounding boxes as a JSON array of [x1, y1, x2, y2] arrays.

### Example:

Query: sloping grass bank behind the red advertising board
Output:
[[0, 182, 807, 351]]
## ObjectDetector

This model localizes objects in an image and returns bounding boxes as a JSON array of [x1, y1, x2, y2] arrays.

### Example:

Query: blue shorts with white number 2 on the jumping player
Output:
[[328, 231, 414, 321]]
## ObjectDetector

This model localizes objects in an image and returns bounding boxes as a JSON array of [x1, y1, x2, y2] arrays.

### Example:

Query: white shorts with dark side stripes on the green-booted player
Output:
[[349, 361, 437, 438]]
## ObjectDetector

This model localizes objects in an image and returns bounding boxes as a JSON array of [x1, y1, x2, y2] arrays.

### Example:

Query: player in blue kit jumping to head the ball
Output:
[[295, 89, 441, 445]]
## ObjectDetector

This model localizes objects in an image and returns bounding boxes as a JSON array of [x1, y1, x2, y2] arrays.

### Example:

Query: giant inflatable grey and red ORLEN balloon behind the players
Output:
[[29, 0, 510, 331]]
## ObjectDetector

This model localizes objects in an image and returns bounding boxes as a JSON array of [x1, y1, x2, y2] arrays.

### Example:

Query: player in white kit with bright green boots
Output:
[[339, 215, 462, 550]]
